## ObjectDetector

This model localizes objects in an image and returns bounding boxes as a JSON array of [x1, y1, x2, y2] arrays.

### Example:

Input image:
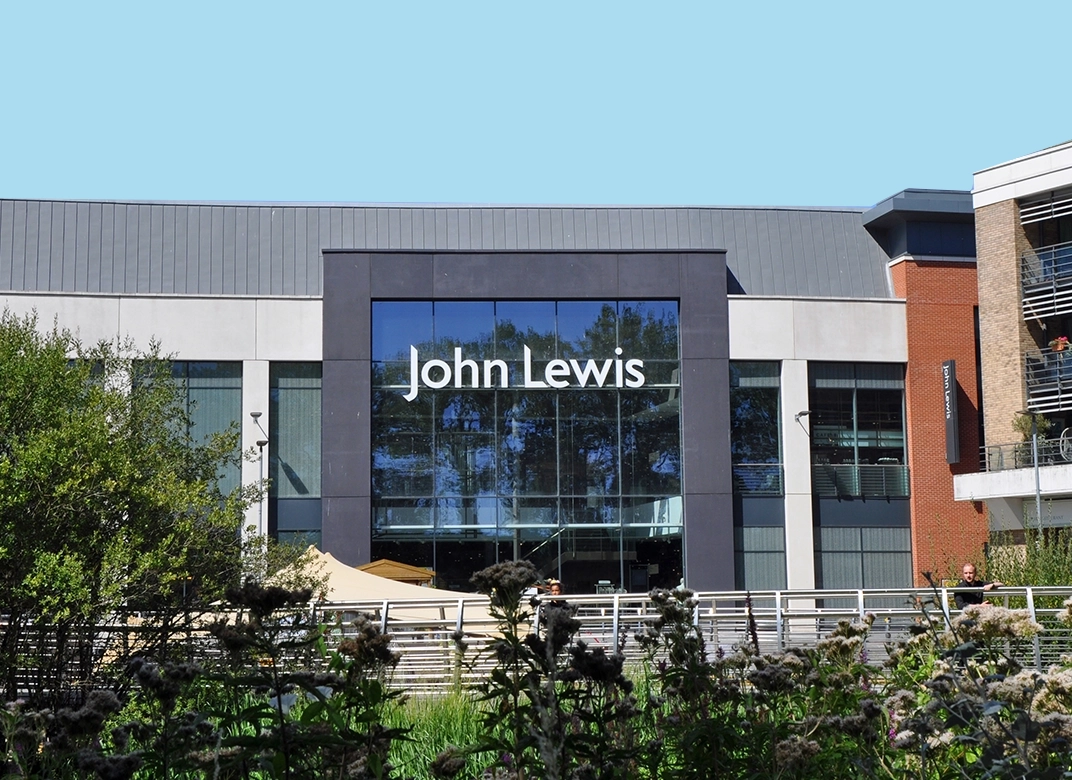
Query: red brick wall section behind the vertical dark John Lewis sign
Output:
[[891, 259, 987, 585]]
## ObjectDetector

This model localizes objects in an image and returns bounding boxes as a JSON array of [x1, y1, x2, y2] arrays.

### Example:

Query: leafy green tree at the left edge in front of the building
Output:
[[0, 311, 260, 698]]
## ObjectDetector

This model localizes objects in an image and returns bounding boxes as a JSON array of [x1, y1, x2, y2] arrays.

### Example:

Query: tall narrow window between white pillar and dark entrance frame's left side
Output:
[[268, 363, 323, 544]]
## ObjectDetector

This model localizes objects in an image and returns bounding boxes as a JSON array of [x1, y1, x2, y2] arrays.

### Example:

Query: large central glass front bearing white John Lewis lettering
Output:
[[372, 300, 682, 593]]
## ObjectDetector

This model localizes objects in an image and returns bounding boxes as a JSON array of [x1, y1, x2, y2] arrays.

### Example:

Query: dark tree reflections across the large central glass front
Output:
[[372, 301, 681, 530]]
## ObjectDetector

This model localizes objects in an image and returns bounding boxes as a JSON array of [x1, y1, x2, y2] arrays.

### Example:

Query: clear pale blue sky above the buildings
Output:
[[0, 0, 1072, 206]]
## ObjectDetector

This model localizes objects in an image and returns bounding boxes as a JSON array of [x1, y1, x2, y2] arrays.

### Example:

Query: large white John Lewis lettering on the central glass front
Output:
[[402, 344, 644, 401]]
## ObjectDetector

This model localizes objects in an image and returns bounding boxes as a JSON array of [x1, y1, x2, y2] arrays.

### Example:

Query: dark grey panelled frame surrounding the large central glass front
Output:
[[322, 250, 734, 590]]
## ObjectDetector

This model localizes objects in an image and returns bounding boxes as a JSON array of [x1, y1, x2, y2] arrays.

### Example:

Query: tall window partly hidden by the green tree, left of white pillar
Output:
[[172, 361, 242, 493]]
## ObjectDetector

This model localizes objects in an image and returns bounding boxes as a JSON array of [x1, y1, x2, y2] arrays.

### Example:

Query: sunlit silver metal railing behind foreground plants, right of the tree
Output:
[[310, 586, 1072, 691]]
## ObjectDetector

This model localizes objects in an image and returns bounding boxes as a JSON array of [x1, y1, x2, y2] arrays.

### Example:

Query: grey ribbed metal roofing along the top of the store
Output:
[[0, 200, 890, 298]]
